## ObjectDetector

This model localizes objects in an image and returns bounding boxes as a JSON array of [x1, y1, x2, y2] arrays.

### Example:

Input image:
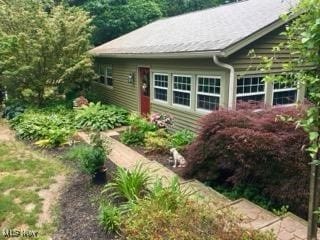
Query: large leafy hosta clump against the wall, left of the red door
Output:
[[75, 102, 128, 131]]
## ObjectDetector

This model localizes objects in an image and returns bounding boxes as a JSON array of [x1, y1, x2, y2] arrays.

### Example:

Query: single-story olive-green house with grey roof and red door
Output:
[[90, 0, 305, 130]]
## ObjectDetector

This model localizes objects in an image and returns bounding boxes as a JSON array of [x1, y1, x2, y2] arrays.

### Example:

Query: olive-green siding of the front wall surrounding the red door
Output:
[[93, 58, 229, 131]]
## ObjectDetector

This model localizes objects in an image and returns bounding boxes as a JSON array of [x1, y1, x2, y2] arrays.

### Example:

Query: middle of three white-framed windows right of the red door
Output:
[[172, 75, 192, 107]]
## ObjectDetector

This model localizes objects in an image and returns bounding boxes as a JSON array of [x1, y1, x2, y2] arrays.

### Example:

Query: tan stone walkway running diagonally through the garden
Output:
[[79, 131, 320, 240]]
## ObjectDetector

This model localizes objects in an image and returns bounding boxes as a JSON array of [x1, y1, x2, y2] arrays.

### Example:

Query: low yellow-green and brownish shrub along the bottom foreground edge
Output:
[[121, 194, 276, 240]]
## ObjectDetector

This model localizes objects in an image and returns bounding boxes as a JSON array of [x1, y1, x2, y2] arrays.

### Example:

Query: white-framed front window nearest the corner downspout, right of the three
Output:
[[197, 76, 221, 111]]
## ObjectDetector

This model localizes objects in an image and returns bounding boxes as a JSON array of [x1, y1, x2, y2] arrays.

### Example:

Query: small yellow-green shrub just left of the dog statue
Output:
[[144, 129, 170, 152]]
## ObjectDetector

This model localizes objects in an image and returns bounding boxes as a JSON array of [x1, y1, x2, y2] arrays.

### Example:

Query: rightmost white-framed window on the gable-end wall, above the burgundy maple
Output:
[[273, 83, 297, 106]]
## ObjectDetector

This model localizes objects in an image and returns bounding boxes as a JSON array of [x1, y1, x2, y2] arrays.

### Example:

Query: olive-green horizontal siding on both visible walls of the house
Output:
[[94, 29, 304, 131]]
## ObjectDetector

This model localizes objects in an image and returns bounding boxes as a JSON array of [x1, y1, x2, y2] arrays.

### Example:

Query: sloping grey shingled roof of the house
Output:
[[90, 0, 298, 57]]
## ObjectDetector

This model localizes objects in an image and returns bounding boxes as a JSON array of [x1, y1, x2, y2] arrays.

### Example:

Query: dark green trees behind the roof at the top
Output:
[[68, 0, 230, 45]]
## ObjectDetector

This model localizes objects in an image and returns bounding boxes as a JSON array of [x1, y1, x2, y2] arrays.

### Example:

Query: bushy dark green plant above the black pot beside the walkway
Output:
[[65, 144, 107, 175]]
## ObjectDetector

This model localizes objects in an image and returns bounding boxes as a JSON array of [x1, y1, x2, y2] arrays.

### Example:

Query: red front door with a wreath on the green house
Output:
[[139, 68, 150, 116]]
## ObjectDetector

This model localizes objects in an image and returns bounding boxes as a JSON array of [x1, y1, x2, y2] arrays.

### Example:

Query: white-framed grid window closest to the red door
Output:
[[153, 73, 169, 102]]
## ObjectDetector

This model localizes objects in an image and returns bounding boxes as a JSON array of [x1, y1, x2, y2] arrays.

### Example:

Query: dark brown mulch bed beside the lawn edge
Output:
[[53, 161, 120, 240]]
